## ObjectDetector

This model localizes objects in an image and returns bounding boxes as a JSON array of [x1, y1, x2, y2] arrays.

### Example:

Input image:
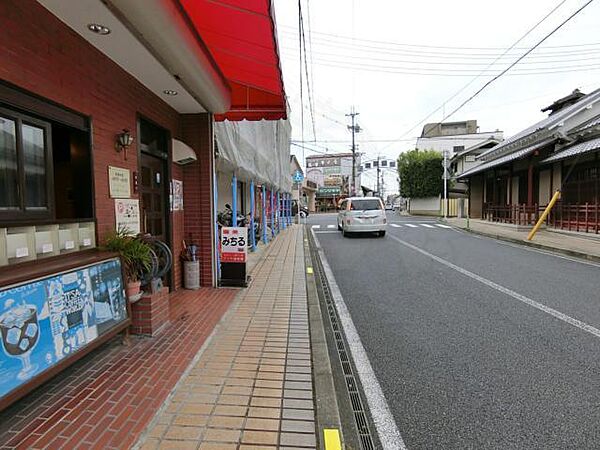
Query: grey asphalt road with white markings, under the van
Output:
[[308, 214, 600, 449]]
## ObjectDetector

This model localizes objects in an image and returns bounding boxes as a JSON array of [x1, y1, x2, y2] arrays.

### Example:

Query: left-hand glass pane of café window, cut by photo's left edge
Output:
[[0, 116, 19, 210]]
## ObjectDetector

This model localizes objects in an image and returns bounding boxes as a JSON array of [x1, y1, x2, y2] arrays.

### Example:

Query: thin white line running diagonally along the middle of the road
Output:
[[390, 236, 600, 337]]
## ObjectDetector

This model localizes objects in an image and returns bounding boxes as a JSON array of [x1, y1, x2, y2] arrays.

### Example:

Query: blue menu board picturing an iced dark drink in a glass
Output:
[[0, 258, 127, 399]]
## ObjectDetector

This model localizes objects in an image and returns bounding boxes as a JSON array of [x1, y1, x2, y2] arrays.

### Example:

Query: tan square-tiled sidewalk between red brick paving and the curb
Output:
[[137, 225, 316, 450]]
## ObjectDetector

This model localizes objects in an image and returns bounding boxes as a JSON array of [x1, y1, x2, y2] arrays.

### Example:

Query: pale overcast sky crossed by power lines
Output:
[[275, 0, 600, 193]]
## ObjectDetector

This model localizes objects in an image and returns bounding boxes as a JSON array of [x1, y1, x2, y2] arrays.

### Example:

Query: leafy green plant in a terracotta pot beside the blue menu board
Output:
[[104, 228, 152, 298]]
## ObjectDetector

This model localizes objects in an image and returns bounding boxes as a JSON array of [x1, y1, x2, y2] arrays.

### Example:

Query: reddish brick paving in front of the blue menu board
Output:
[[0, 288, 238, 449]]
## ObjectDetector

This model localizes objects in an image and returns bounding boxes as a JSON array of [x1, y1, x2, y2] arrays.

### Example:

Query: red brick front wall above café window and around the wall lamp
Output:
[[0, 0, 195, 287]]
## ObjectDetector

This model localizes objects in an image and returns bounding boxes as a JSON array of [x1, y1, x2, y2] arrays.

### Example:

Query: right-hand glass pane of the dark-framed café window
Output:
[[21, 124, 48, 209]]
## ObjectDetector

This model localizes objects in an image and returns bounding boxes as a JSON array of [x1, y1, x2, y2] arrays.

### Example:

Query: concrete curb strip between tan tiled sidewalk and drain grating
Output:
[[303, 228, 344, 450]]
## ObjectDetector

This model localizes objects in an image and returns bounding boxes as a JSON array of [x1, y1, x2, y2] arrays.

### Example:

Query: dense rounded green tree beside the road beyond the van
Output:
[[398, 149, 444, 198]]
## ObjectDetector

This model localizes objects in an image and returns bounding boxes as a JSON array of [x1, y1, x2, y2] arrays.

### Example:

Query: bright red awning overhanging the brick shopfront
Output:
[[179, 0, 287, 120]]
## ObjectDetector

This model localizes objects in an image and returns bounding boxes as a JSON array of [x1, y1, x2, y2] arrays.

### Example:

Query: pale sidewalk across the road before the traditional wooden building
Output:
[[447, 218, 600, 261]]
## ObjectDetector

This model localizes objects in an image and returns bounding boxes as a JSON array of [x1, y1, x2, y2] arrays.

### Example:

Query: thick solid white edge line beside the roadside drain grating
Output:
[[313, 231, 406, 450]]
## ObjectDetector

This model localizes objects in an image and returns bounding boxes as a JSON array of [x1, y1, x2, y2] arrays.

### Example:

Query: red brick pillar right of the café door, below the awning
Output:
[[181, 114, 213, 286]]
